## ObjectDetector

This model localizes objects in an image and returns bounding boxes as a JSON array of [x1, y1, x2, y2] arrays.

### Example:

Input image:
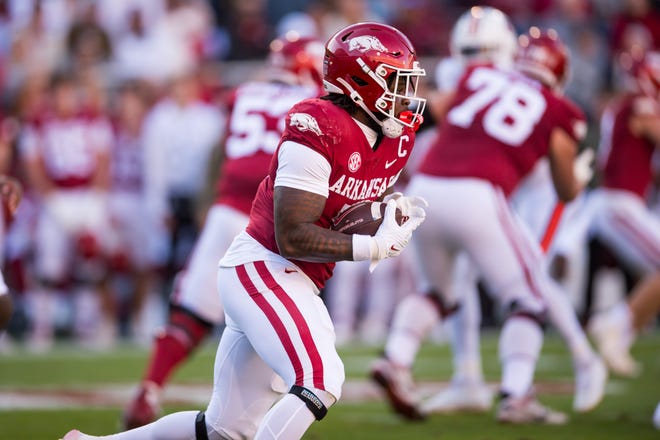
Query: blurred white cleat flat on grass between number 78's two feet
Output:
[[420, 381, 493, 415]]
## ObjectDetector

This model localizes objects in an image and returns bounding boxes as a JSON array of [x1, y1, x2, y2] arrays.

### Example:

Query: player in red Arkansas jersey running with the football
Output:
[[58, 23, 425, 440]]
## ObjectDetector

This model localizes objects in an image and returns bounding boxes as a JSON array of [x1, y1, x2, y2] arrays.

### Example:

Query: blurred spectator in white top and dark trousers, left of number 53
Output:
[[144, 72, 225, 280]]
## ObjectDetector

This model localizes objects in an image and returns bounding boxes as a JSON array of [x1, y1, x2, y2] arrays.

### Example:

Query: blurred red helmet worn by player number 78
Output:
[[514, 27, 569, 89]]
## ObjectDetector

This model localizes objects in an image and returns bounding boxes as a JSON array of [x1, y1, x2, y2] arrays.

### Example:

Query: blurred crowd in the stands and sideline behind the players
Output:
[[0, 0, 660, 350]]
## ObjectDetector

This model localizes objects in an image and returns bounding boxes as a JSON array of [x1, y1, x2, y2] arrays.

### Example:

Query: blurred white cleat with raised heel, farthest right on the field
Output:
[[589, 310, 641, 377]]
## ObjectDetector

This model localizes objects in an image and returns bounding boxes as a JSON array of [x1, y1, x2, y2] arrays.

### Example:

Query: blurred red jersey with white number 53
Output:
[[216, 82, 318, 214]]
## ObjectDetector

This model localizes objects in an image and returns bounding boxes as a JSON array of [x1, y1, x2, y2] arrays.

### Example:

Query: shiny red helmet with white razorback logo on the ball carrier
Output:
[[323, 23, 426, 137]]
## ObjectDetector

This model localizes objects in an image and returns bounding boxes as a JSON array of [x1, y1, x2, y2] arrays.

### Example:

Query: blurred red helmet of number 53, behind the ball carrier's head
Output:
[[269, 32, 325, 88]]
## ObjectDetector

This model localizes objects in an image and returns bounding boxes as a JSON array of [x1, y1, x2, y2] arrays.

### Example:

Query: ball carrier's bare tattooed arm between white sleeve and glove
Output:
[[274, 186, 353, 262]]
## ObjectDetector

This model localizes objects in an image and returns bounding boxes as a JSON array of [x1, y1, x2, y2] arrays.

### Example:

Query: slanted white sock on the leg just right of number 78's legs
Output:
[[544, 282, 596, 365]]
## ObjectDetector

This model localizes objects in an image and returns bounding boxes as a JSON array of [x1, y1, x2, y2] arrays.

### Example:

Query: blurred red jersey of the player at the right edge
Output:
[[598, 95, 660, 198]]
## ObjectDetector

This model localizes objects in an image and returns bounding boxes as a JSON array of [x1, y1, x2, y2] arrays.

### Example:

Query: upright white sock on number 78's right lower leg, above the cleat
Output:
[[499, 316, 543, 397]]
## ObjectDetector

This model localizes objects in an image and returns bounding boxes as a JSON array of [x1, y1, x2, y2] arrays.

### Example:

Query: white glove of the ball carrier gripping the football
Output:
[[369, 198, 428, 272]]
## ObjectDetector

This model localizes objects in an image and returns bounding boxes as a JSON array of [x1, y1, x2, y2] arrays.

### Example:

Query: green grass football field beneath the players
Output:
[[0, 331, 660, 440]]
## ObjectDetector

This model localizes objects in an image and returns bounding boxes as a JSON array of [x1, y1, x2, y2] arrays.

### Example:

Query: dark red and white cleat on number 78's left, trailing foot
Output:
[[371, 358, 426, 420]]
